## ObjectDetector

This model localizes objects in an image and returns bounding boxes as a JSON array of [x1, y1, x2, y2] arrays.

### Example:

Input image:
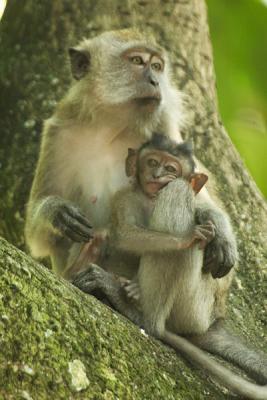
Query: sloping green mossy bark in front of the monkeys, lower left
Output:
[[0, 239, 228, 400]]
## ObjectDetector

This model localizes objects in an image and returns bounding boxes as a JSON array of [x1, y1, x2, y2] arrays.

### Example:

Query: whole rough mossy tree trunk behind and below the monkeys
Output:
[[0, 0, 267, 400]]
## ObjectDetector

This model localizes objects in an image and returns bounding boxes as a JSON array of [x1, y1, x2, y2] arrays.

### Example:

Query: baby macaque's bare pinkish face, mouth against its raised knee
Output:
[[138, 149, 182, 197]]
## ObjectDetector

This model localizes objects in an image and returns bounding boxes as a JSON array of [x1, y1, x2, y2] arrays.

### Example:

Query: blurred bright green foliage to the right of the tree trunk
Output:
[[206, 0, 267, 198]]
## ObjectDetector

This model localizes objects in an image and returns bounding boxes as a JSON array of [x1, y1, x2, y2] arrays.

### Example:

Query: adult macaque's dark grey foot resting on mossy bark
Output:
[[72, 264, 143, 326]]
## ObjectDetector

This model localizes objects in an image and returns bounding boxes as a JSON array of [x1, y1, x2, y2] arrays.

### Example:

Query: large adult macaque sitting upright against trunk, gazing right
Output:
[[25, 30, 236, 277]]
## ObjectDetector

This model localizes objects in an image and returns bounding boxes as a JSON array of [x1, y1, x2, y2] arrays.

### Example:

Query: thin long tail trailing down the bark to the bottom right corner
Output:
[[161, 331, 267, 400]]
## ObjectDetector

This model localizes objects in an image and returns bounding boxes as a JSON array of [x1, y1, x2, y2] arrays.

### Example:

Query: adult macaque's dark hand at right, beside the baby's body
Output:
[[203, 237, 237, 278]]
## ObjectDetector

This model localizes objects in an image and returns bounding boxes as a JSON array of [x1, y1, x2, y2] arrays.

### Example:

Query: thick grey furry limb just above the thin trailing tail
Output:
[[191, 320, 267, 384]]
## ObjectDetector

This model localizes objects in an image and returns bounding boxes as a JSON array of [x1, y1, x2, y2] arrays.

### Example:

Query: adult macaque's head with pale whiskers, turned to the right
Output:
[[69, 29, 181, 118]]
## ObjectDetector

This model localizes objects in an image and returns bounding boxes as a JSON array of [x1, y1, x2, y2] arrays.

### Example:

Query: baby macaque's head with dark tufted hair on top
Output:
[[126, 133, 197, 197]]
